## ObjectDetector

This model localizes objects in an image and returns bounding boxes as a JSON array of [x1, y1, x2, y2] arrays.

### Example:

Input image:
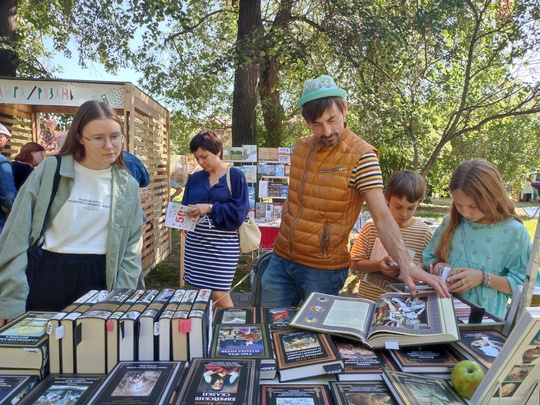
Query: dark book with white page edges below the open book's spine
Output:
[[332, 336, 396, 381]]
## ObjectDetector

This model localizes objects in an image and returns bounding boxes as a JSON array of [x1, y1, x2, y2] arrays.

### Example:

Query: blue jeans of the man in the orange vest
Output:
[[261, 254, 349, 307]]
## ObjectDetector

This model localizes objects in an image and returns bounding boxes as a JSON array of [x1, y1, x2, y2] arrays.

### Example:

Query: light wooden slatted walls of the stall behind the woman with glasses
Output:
[[0, 83, 171, 274]]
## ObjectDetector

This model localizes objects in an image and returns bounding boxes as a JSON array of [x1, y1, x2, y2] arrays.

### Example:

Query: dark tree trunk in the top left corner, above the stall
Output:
[[0, 0, 19, 77]]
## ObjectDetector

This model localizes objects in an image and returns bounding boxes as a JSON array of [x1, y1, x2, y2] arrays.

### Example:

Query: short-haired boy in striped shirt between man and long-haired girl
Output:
[[343, 170, 432, 295]]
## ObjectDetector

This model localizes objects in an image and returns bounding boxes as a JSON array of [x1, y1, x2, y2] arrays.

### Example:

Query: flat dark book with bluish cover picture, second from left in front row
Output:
[[19, 374, 105, 405]]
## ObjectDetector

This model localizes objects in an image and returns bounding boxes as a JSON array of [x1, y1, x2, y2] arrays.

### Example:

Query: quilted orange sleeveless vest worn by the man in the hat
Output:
[[274, 127, 377, 270]]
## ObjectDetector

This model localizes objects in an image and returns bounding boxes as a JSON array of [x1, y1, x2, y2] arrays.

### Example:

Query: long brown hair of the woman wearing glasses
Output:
[[58, 100, 127, 170]]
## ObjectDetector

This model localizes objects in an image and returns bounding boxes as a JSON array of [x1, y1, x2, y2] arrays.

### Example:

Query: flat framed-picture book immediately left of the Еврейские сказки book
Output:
[[88, 361, 187, 405]]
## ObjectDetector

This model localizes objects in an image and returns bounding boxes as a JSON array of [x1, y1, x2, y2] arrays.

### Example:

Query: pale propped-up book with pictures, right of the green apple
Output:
[[471, 307, 540, 405]]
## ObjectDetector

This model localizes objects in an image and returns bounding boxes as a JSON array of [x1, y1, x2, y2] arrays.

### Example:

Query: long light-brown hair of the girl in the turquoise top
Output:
[[435, 159, 522, 262]]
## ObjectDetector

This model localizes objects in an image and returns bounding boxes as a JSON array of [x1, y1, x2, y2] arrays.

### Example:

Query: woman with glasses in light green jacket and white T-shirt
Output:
[[0, 101, 143, 325]]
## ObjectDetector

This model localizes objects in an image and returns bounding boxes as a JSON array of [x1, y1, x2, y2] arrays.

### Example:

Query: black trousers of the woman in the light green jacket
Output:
[[26, 246, 107, 312]]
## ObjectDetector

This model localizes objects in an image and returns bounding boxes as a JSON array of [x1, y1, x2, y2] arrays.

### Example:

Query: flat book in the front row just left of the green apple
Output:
[[383, 370, 464, 405]]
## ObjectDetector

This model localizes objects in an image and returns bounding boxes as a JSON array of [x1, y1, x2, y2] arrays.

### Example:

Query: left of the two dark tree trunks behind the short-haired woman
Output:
[[232, 0, 261, 146]]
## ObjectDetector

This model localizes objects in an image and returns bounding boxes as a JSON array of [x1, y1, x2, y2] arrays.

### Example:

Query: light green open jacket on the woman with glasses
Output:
[[0, 155, 143, 319]]
